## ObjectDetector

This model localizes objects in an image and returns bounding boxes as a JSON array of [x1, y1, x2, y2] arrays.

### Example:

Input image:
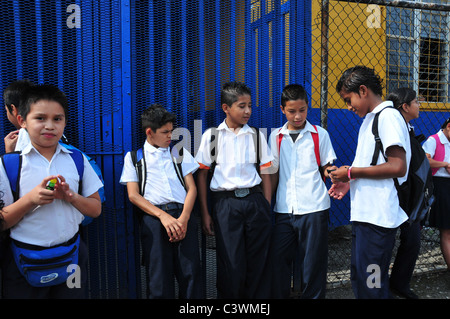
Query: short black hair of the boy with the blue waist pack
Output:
[[19, 84, 69, 122]]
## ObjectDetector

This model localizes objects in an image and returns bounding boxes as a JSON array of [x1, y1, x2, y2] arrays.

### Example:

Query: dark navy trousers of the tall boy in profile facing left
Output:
[[350, 222, 397, 299]]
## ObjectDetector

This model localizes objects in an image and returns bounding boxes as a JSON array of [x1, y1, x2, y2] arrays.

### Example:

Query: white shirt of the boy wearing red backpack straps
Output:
[[269, 121, 336, 215]]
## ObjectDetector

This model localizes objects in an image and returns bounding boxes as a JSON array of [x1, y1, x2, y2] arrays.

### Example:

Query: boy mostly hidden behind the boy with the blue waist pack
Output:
[[3, 80, 33, 153]]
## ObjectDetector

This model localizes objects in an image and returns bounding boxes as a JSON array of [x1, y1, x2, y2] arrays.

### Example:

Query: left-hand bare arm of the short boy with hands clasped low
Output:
[[127, 182, 183, 241]]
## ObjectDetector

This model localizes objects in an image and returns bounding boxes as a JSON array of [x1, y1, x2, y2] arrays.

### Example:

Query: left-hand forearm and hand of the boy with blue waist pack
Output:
[[2, 176, 56, 229]]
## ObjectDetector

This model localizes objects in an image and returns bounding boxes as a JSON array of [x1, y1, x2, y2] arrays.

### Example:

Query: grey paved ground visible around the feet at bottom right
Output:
[[326, 271, 450, 299]]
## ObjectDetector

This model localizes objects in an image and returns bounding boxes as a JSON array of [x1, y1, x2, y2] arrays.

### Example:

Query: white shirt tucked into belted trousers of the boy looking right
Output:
[[195, 121, 273, 191]]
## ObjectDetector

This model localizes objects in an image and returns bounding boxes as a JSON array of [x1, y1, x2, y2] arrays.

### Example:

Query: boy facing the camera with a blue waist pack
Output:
[[0, 85, 102, 298]]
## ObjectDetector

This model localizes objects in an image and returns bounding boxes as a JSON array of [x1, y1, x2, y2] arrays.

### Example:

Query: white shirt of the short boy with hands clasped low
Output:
[[120, 141, 199, 205]]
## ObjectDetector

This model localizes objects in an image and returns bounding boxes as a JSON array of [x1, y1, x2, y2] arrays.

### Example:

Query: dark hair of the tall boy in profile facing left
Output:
[[336, 65, 383, 96]]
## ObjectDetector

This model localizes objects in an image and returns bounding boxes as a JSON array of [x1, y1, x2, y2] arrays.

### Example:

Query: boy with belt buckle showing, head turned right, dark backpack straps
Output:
[[196, 82, 272, 298]]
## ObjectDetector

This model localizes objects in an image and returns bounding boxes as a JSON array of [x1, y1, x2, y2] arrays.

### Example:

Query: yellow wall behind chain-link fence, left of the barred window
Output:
[[311, 0, 386, 108]]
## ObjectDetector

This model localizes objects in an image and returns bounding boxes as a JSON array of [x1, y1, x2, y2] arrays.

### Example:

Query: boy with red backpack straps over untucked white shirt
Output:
[[269, 84, 337, 298]]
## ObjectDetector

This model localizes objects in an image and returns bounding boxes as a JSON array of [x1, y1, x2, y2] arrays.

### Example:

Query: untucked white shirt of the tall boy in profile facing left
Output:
[[350, 101, 411, 228]]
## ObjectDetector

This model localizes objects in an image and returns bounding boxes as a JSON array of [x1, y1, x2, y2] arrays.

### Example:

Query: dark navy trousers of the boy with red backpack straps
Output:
[[270, 210, 328, 299]]
